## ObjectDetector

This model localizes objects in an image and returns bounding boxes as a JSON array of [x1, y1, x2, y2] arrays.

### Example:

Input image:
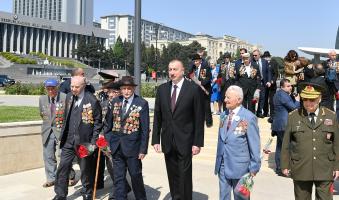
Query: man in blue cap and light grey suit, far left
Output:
[[39, 79, 66, 187]]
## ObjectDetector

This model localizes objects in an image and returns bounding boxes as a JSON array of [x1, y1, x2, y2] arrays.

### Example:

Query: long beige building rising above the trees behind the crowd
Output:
[[151, 33, 263, 61]]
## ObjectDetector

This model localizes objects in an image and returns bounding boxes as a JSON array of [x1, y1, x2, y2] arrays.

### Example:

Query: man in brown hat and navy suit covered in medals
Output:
[[104, 76, 149, 200]]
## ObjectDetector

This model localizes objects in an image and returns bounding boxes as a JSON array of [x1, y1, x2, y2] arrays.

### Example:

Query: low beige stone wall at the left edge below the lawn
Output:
[[0, 121, 44, 175]]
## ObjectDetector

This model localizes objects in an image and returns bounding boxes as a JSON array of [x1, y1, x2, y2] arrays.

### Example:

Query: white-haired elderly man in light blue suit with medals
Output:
[[214, 85, 261, 200]]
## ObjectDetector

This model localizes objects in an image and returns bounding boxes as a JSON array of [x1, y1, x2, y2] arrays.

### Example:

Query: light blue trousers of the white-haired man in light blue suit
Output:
[[218, 161, 250, 200]]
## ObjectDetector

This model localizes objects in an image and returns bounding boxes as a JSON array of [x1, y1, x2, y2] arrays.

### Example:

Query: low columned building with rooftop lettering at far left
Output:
[[0, 11, 109, 58]]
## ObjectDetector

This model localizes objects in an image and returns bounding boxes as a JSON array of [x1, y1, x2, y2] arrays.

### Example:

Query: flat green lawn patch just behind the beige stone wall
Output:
[[0, 106, 41, 123]]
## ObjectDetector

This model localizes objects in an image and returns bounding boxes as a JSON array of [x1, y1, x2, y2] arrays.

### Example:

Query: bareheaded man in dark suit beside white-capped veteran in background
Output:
[[252, 49, 271, 118]]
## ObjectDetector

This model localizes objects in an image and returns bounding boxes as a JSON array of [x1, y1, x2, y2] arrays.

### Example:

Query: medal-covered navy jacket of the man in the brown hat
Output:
[[104, 95, 149, 157]]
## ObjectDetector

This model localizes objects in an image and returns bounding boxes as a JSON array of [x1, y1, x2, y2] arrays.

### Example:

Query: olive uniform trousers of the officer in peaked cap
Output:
[[293, 180, 333, 200]]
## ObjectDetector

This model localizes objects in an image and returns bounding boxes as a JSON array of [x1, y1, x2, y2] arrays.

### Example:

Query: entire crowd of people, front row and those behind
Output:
[[39, 48, 339, 200]]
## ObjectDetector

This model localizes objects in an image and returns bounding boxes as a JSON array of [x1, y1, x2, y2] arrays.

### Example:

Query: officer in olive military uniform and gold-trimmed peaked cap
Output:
[[281, 82, 339, 200]]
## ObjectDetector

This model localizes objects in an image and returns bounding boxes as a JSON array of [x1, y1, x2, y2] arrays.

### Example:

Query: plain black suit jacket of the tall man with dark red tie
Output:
[[152, 79, 205, 155]]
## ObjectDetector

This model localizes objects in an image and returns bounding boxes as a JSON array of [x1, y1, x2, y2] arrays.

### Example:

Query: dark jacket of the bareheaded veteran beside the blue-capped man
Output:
[[60, 92, 102, 148]]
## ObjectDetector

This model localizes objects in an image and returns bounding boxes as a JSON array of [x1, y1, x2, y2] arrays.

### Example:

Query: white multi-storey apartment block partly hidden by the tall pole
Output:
[[101, 15, 194, 48]]
